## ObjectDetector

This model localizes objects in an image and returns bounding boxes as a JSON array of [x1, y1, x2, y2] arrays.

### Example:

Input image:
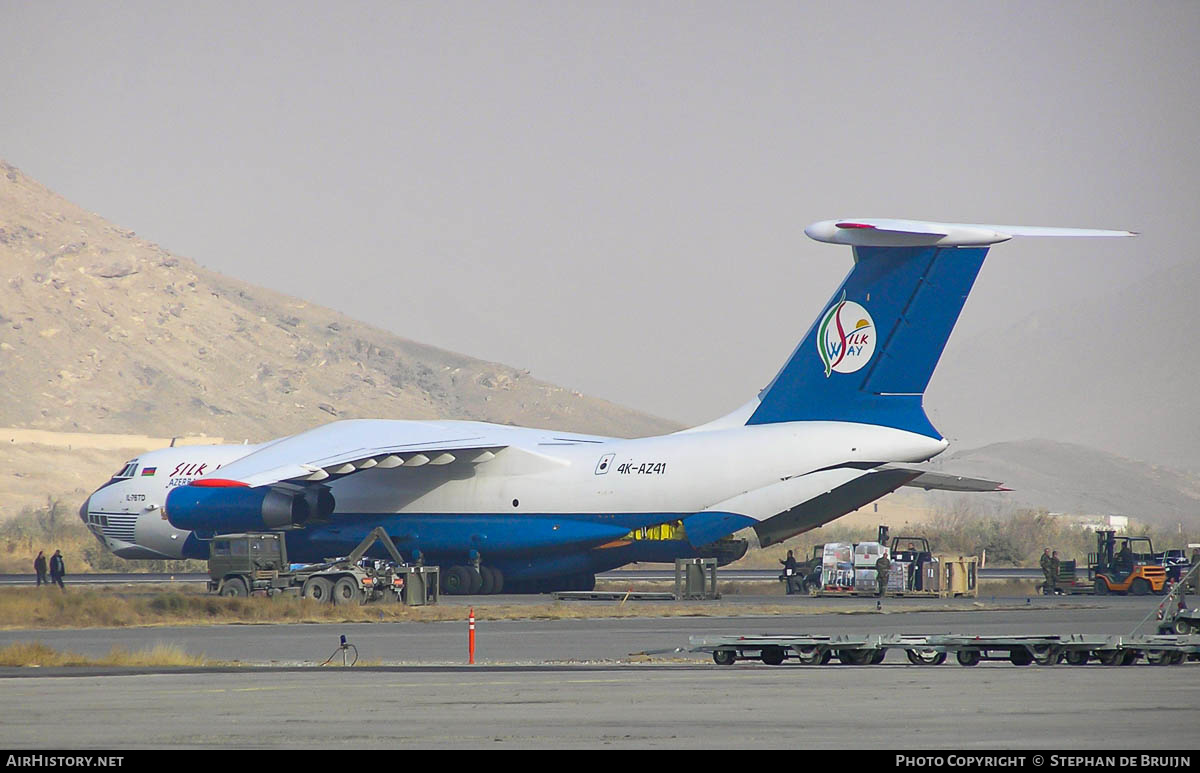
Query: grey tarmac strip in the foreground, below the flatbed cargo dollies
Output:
[[0, 665, 1200, 753]]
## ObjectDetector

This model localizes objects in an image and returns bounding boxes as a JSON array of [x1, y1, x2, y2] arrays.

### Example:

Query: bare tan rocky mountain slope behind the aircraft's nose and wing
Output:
[[0, 163, 677, 441]]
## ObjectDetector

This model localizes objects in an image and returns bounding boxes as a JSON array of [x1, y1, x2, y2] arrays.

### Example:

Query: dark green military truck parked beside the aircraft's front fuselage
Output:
[[208, 527, 438, 605]]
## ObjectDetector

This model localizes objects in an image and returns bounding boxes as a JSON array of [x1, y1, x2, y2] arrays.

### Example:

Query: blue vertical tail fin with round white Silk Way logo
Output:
[[746, 246, 988, 438]]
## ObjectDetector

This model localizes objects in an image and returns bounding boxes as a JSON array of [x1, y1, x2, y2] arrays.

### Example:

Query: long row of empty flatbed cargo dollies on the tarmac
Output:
[[691, 634, 1200, 666]]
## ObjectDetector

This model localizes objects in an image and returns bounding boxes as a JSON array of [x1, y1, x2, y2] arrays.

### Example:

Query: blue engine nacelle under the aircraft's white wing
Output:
[[163, 485, 334, 533]]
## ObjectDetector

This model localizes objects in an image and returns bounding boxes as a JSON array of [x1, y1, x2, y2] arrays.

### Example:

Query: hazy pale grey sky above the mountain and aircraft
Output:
[[0, 0, 1200, 423]]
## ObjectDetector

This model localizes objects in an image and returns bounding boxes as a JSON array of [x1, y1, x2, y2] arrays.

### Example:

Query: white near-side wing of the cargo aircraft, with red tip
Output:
[[192, 419, 508, 487]]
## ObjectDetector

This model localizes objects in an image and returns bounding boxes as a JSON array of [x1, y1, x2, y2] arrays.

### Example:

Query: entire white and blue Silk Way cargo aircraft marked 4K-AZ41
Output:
[[80, 218, 1133, 593]]
